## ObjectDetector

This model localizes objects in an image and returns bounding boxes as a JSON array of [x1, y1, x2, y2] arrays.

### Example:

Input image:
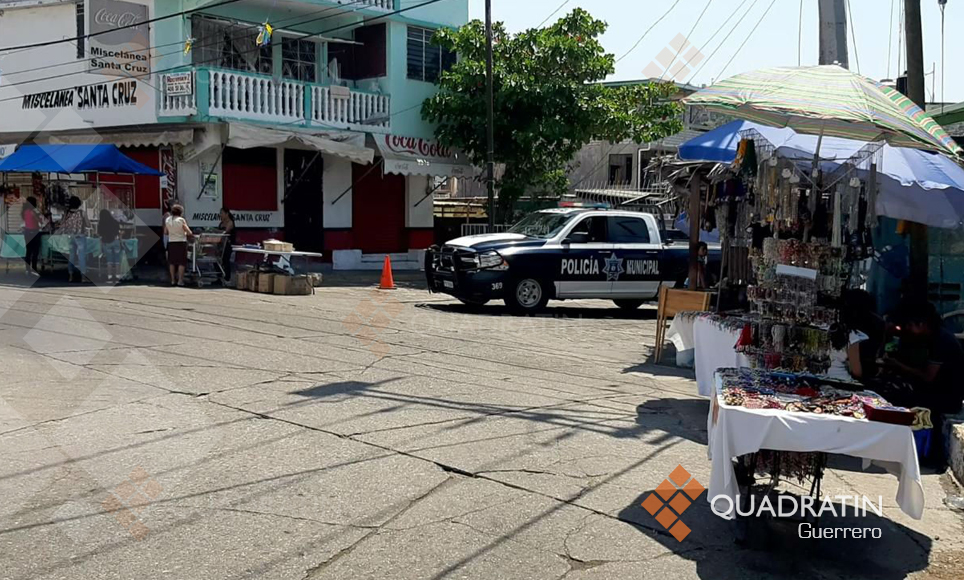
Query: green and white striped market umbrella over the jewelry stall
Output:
[[683, 65, 964, 158]]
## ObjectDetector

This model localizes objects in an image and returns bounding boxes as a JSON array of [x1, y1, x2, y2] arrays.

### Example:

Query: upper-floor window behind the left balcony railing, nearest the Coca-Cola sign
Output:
[[191, 15, 274, 75]]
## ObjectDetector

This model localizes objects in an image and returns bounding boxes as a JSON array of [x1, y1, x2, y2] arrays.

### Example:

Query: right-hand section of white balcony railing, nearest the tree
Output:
[[311, 87, 392, 133]]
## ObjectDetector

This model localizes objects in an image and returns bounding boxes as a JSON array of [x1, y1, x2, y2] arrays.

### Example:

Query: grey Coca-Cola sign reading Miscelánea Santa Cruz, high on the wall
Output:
[[87, 0, 151, 76]]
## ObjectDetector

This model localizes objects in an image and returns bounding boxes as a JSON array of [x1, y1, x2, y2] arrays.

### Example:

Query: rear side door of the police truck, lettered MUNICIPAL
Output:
[[606, 215, 662, 300]]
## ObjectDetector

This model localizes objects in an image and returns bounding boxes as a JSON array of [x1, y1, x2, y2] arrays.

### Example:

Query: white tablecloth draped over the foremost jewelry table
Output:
[[707, 377, 924, 520]]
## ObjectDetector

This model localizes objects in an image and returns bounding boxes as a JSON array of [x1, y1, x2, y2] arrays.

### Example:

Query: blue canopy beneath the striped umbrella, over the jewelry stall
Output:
[[679, 121, 964, 228]]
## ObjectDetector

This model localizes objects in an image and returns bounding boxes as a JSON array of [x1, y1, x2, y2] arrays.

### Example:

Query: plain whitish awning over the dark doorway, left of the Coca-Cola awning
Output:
[[226, 123, 375, 165]]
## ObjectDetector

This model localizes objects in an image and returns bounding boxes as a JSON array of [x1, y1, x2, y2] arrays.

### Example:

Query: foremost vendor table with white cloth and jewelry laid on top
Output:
[[707, 369, 924, 519]]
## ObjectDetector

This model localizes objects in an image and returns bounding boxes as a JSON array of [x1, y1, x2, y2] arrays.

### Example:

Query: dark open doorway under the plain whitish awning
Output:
[[284, 149, 325, 252]]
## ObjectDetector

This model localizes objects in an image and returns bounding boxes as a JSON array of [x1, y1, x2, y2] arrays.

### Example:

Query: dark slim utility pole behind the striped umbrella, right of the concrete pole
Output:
[[904, 0, 929, 296]]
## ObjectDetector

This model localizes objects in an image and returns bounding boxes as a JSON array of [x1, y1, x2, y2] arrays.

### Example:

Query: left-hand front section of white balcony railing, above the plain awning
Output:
[[208, 70, 305, 122]]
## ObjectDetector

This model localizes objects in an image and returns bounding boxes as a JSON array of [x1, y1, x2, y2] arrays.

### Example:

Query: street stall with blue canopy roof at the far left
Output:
[[0, 145, 161, 280]]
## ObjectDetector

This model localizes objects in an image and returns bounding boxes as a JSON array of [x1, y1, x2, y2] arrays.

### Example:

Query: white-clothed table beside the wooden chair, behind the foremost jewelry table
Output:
[[666, 312, 750, 399]]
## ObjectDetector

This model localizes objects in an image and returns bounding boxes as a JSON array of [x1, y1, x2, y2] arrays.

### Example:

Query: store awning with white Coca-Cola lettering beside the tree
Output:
[[375, 135, 475, 177]]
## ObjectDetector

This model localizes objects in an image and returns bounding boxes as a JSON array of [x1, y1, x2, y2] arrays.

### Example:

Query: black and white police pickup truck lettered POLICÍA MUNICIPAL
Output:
[[425, 208, 719, 313]]
